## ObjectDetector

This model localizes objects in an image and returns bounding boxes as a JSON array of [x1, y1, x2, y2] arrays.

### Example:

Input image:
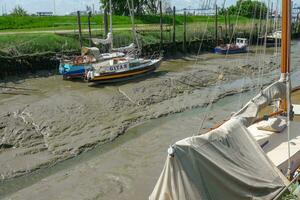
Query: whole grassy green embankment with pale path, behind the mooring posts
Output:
[[0, 15, 264, 55]]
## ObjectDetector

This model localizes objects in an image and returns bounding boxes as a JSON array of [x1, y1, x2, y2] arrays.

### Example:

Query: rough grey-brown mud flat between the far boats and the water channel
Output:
[[0, 50, 278, 180]]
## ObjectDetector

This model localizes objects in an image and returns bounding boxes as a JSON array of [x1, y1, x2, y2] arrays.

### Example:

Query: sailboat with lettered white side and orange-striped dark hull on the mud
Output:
[[85, 57, 161, 83]]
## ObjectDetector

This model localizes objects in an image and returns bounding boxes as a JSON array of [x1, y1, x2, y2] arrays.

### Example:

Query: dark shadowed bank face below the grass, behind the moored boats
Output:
[[0, 36, 282, 80]]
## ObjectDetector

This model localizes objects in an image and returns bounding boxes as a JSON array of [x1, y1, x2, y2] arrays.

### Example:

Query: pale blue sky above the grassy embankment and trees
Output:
[[0, 0, 300, 15]]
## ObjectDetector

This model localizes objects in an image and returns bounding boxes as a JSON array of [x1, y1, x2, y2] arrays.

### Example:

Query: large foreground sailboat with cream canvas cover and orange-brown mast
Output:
[[149, 0, 300, 200]]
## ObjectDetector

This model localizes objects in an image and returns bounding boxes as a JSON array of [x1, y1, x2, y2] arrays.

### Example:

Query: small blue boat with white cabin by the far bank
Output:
[[214, 38, 248, 54]]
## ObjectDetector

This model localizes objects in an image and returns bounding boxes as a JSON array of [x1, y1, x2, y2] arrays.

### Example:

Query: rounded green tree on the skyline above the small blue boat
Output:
[[220, 0, 268, 19]]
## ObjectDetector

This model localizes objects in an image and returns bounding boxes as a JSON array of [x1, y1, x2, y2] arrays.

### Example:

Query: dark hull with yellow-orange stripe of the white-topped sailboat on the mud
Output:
[[87, 60, 161, 83]]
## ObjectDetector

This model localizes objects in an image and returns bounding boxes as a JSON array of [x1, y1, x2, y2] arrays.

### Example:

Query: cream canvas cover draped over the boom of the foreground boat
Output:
[[149, 82, 287, 200]]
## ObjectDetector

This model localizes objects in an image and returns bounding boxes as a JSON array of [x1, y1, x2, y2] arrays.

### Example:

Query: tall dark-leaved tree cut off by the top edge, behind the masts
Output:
[[100, 0, 157, 15]]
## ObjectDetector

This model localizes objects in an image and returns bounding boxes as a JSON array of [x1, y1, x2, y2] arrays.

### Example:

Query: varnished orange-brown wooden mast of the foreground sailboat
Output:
[[281, 0, 292, 177]]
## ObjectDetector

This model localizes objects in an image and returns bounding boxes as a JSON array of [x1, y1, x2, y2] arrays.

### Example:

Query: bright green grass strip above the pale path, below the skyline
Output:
[[0, 15, 254, 32]]
